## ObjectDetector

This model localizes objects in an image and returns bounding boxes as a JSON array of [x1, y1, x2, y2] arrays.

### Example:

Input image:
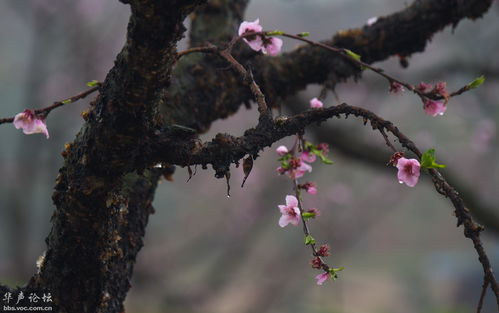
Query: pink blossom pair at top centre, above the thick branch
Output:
[[238, 19, 282, 56]]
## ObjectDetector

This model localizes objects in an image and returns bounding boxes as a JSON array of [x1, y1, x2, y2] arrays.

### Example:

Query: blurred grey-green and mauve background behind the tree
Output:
[[0, 0, 499, 313]]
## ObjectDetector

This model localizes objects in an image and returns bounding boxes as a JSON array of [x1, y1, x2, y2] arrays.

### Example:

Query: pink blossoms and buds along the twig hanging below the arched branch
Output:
[[276, 140, 342, 285]]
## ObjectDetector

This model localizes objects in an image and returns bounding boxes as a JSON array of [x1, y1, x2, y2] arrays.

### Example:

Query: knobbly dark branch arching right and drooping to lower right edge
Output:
[[153, 103, 499, 307]]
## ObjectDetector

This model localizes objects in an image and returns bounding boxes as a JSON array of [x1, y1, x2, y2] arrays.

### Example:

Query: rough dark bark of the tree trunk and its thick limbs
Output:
[[0, 0, 499, 313]]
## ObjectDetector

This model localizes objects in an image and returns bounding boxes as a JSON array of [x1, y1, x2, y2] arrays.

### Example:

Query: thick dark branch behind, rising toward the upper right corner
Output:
[[169, 0, 492, 131]]
